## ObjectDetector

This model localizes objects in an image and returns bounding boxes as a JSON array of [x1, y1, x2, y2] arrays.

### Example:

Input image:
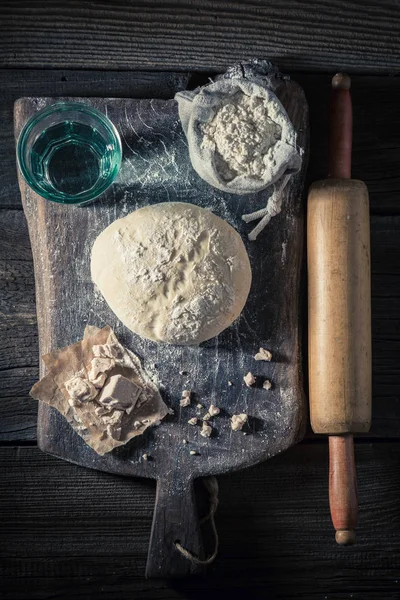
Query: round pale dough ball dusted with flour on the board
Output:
[[91, 202, 251, 344]]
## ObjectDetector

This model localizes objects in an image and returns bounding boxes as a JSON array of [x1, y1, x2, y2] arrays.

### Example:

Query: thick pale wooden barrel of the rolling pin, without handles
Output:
[[307, 180, 371, 434]]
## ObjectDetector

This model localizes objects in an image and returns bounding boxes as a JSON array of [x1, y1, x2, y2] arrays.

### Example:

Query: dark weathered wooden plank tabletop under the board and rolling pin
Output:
[[0, 0, 400, 600]]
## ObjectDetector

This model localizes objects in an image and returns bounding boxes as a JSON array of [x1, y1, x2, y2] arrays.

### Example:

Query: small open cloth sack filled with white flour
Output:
[[175, 61, 301, 194]]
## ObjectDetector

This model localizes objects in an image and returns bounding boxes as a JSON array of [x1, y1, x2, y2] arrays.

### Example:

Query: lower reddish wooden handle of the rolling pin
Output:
[[329, 433, 358, 546]]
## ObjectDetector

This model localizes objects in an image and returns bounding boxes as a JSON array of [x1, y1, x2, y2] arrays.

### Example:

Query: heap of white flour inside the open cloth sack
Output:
[[202, 92, 282, 181]]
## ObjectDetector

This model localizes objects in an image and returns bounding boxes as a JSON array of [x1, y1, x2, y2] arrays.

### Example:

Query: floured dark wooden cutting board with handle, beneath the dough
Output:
[[15, 74, 308, 577]]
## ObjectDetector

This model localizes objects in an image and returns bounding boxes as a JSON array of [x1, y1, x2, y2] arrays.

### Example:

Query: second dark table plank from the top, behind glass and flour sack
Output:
[[0, 69, 400, 214]]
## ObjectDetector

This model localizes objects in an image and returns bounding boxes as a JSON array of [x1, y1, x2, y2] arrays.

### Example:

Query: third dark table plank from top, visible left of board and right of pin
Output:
[[0, 210, 400, 443]]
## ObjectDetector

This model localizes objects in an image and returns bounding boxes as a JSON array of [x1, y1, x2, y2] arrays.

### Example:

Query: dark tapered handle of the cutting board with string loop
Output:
[[146, 478, 204, 578]]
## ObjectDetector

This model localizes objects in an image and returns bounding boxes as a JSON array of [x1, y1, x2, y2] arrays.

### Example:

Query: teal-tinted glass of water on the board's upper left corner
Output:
[[17, 102, 122, 204]]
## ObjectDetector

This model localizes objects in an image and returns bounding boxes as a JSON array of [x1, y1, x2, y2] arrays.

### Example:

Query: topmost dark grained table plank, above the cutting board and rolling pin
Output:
[[0, 0, 400, 73]]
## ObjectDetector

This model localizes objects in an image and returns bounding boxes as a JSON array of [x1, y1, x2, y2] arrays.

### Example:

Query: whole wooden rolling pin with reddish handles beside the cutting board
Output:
[[307, 73, 371, 545]]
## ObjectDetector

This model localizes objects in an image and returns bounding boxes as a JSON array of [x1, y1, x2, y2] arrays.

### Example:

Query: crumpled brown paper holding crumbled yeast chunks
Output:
[[30, 325, 171, 455]]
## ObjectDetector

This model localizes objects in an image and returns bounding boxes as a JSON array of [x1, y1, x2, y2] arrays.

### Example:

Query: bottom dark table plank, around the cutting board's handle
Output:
[[0, 443, 400, 600]]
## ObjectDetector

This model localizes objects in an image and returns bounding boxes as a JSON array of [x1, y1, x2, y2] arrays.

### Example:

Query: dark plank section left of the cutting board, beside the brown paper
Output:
[[0, 210, 39, 442]]
